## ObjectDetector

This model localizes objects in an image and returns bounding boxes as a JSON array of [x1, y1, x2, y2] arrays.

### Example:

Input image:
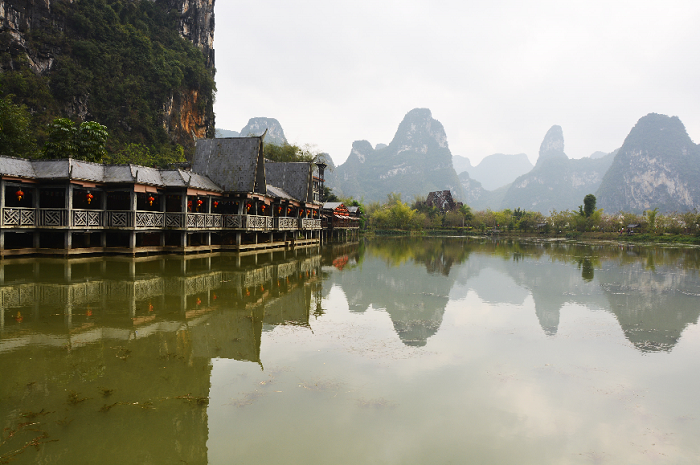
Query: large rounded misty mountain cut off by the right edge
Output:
[[596, 113, 700, 213]]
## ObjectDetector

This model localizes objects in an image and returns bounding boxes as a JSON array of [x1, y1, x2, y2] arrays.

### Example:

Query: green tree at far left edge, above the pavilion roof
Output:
[[0, 95, 36, 157]]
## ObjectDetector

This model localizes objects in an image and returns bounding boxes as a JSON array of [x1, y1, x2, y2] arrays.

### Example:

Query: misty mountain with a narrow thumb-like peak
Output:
[[502, 126, 614, 213]]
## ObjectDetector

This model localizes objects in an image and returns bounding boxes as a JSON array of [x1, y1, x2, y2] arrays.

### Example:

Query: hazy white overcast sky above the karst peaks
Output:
[[214, 0, 700, 164]]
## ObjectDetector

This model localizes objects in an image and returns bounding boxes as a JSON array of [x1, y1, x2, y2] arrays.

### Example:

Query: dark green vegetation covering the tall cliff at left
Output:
[[0, 0, 215, 157]]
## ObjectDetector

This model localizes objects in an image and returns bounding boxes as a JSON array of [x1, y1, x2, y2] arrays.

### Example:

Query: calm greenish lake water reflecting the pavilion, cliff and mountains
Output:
[[0, 238, 700, 464]]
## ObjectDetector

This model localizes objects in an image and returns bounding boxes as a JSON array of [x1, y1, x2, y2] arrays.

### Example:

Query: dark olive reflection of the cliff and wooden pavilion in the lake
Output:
[[0, 252, 321, 464]]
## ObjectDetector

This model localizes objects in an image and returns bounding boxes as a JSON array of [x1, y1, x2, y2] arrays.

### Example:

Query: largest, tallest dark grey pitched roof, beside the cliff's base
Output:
[[192, 137, 267, 194]]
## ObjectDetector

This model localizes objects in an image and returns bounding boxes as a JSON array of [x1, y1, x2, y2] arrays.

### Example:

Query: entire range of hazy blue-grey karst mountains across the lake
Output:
[[217, 108, 700, 213]]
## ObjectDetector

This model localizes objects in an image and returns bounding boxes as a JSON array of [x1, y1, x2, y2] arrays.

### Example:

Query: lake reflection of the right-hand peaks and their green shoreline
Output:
[[453, 241, 700, 352]]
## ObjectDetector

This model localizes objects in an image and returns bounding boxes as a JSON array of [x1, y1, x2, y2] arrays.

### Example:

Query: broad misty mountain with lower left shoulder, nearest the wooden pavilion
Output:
[[326, 108, 464, 201]]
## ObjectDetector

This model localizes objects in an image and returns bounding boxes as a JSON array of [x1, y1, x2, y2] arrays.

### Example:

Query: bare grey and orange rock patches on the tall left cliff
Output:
[[0, 0, 215, 147]]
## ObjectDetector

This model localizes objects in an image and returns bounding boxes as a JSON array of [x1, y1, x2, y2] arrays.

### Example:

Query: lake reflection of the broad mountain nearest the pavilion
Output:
[[326, 239, 469, 346]]
